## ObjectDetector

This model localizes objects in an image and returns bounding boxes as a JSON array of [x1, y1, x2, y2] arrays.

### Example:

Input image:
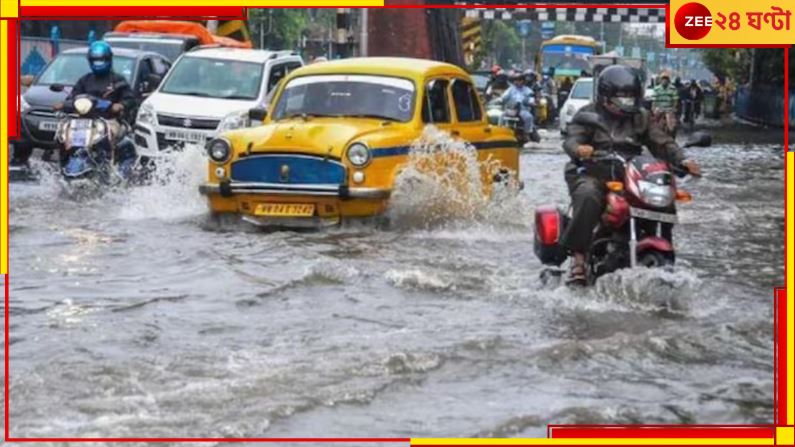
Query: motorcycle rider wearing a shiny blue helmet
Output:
[[56, 40, 135, 162]]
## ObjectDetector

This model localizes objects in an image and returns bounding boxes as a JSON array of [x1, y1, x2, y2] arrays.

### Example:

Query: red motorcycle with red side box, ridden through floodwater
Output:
[[533, 112, 712, 284]]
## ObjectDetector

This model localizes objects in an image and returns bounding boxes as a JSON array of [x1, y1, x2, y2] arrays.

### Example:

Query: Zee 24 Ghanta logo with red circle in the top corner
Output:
[[674, 2, 792, 40]]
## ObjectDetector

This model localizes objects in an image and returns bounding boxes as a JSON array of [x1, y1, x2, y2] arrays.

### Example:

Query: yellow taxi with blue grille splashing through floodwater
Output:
[[199, 58, 519, 227]]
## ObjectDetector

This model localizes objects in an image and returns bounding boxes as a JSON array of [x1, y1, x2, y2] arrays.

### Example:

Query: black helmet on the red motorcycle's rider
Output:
[[596, 65, 643, 115]]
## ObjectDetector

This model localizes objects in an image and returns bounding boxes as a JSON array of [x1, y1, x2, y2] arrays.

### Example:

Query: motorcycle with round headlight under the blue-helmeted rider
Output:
[[55, 95, 138, 185]]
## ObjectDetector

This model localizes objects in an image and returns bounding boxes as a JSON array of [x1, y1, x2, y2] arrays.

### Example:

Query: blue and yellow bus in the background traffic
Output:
[[536, 34, 600, 81]]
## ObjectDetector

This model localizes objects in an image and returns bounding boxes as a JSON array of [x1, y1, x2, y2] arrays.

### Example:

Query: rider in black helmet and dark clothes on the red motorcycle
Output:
[[561, 65, 700, 284]]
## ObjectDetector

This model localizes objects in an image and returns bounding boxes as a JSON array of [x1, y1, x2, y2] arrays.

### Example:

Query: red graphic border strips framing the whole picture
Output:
[[4, 4, 789, 447]]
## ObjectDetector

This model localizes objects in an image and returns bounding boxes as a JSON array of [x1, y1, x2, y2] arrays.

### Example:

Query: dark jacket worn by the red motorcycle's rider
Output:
[[563, 103, 685, 166]]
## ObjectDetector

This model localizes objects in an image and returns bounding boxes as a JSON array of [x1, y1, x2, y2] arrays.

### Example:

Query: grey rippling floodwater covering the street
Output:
[[4, 124, 784, 437]]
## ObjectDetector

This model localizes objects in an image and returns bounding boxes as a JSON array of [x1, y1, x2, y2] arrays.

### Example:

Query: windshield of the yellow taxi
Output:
[[273, 75, 415, 122]]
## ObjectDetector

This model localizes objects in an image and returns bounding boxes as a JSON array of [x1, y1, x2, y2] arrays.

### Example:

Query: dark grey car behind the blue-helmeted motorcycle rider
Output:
[[14, 48, 170, 158]]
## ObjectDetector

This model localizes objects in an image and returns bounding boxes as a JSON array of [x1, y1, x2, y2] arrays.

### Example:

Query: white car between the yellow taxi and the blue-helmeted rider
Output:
[[135, 47, 304, 157]]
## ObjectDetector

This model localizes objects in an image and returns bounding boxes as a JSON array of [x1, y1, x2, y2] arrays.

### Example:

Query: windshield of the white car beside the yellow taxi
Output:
[[160, 57, 263, 99]]
